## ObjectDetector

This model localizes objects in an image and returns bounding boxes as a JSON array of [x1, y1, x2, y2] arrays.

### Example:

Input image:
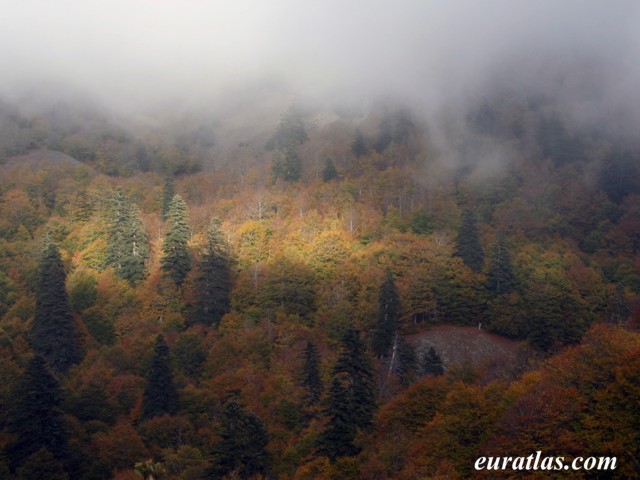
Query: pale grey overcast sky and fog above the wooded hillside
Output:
[[0, 0, 640, 114]]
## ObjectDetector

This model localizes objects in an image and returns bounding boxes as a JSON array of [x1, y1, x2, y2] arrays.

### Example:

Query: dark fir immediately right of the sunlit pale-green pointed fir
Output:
[[190, 218, 231, 327]]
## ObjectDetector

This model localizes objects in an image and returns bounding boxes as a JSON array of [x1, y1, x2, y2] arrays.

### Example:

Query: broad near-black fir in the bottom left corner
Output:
[[6, 355, 70, 471]]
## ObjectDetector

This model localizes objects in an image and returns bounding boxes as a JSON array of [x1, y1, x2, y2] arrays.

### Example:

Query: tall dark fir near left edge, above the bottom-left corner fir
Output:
[[31, 242, 82, 372]]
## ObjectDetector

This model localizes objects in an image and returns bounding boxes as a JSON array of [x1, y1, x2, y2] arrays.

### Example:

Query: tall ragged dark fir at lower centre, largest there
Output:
[[318, 329, 376, 459]]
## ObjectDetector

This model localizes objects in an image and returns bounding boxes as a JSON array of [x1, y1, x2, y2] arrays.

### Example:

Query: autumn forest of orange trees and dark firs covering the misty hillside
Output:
[[0, 82, 640, 480]]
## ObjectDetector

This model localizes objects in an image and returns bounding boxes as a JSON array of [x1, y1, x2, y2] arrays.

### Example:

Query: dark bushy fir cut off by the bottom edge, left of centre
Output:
[[208, 400, 271, 478]]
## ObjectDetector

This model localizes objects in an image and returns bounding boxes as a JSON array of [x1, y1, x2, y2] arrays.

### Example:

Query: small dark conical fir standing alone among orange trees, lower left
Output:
[[142, 335, 178, 418]]
